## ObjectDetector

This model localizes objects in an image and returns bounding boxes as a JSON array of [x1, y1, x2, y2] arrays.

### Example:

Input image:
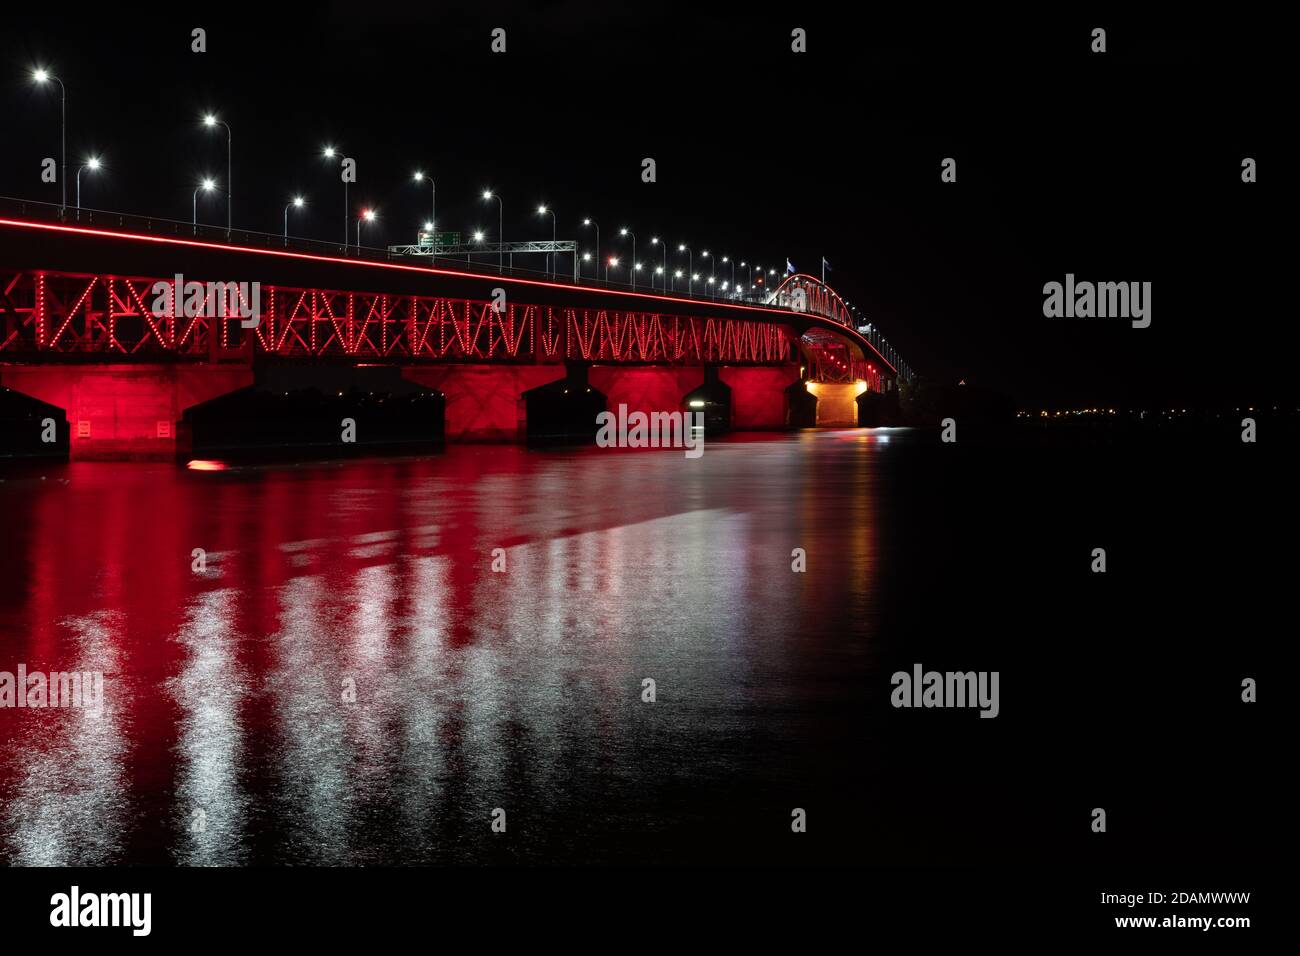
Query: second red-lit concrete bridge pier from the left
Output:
[[402, 365, 564, 441]]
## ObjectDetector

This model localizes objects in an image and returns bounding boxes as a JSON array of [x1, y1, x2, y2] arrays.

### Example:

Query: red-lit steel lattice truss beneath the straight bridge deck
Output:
[[0, 271, 796, 365]]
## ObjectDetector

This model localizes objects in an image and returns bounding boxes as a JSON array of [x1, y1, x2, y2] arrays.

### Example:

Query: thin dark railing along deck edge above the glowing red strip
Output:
[[0, 196, 767, 306]]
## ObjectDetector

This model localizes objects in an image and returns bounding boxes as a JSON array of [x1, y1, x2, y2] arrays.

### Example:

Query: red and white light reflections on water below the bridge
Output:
[[0, 434, 883, 865]]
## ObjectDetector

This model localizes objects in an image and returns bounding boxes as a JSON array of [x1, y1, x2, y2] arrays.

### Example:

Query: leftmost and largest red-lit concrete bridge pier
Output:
[[0, 364, 252, 460]]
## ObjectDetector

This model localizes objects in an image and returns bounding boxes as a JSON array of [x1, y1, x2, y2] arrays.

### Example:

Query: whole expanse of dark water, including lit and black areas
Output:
[[0, 429, 1279, 865]]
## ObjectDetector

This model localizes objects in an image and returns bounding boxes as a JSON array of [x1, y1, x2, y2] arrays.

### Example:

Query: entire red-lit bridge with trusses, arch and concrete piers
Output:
[[0, 208, 900, 458]]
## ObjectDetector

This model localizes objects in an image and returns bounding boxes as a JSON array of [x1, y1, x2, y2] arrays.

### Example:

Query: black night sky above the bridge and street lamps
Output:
[[0, 1, 1279, 407]]
